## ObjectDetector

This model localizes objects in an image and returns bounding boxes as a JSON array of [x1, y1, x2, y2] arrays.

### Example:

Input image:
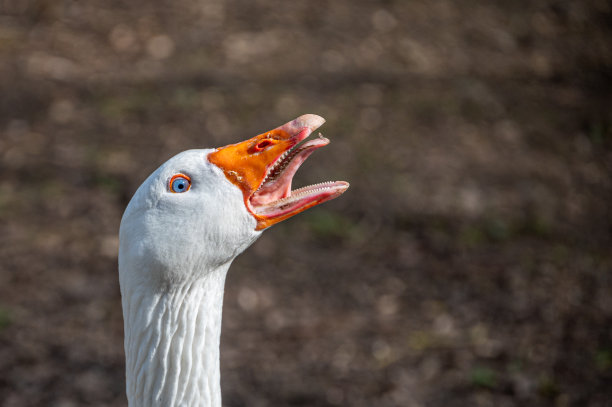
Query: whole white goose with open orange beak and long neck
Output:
[[118, 114, 349, 407]]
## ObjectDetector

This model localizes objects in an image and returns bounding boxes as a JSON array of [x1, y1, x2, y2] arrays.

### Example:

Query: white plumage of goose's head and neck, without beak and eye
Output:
[[119, 150, 261, 407]]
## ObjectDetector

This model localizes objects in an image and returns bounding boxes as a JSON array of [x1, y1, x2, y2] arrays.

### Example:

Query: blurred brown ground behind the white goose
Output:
[[0, 0, 612, 407]]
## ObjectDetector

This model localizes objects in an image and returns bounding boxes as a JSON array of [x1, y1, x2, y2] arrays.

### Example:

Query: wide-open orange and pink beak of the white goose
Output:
[[208, 114, 349, 230]]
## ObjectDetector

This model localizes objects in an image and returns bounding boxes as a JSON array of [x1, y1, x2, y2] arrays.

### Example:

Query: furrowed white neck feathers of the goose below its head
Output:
[[122, 264, 229, 407]]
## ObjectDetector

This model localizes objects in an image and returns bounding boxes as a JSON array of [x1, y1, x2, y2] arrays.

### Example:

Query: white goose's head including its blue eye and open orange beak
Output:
[[119, 114, 348, 291]]
